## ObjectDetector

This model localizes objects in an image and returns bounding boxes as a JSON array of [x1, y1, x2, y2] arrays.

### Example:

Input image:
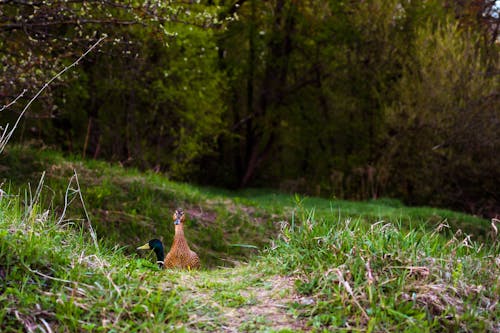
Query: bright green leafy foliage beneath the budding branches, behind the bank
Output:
[[57, 22, 228, 179]]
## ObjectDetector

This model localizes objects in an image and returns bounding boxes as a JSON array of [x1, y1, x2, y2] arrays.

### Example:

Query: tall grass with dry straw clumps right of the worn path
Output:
[[265, 201, 500, 332]]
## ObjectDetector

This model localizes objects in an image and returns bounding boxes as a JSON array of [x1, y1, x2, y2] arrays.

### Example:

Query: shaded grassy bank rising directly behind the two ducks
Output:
[[0, 147, 276, 267]]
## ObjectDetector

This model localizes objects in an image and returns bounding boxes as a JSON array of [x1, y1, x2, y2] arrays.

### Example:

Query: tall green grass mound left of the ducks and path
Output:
[[0, 193, 191, 332]]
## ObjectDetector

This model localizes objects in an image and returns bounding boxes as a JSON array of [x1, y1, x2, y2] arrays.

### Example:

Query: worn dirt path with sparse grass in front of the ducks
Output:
[[174, 268, 307, 332]]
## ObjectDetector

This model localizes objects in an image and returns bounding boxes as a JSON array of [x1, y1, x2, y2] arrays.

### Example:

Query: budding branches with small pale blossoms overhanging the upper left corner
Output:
[[0, 0, 219, 103]]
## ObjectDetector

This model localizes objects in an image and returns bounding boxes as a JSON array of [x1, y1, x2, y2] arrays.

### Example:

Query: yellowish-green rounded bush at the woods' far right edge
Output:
[[379, 22, 500, 215]]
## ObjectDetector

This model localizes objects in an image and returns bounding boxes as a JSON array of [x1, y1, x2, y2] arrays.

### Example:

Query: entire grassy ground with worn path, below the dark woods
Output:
[[0, 148, 500, 332]]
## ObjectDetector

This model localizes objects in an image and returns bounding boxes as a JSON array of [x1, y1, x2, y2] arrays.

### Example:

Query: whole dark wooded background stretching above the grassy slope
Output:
[[0, 0, 500, 217]]
